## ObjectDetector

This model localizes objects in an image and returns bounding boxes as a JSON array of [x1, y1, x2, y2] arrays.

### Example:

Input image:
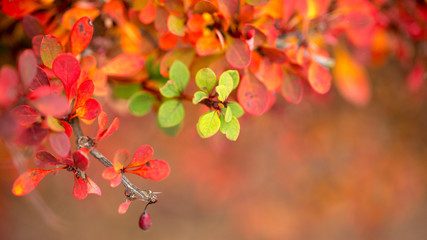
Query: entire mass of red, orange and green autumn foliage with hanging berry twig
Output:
[[0, 0, 427, 230]]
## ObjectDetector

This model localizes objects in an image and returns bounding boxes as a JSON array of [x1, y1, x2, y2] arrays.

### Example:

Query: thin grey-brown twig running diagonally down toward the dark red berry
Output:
[[70, 118, 157, 203]]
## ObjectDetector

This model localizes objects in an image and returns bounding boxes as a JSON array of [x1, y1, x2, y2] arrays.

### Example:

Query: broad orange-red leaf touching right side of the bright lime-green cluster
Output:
[[237, 72, 270, 116]]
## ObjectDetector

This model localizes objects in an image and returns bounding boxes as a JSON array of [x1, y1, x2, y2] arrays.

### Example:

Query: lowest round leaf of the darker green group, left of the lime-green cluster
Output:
[[158, 99, 185, 128]]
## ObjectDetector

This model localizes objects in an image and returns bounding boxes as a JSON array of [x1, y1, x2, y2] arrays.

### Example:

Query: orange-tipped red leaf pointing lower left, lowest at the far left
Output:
[[12, 168, 62, 196]]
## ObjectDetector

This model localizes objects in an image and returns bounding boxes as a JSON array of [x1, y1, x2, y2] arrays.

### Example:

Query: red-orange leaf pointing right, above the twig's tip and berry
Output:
[[125, 159, 170, 181]]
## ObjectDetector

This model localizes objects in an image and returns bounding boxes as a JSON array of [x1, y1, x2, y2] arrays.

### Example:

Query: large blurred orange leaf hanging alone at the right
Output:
[[333, 46, 371, 106]]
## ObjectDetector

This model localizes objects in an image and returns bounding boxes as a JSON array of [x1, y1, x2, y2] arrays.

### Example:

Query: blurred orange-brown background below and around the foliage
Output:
[[0, 57, 427, 240]]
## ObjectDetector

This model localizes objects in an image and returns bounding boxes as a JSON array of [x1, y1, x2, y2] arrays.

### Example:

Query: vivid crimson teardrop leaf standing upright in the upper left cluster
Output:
[[52, 53, 81, 99]]
